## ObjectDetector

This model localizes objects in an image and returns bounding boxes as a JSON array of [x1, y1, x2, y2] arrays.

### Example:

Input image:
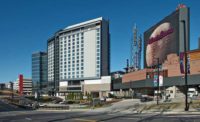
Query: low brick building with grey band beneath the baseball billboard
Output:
[[112, 49, 200, 98]]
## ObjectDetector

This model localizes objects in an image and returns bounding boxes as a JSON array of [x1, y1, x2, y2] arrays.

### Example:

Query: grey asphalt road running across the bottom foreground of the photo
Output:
[[0, 111, 200, 122]]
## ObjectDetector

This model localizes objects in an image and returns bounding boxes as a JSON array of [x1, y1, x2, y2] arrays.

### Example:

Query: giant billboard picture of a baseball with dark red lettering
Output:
[[144, 11, 179, 67]]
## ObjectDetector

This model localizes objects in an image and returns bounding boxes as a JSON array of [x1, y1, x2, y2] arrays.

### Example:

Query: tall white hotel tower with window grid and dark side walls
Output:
[[48, 17, 110, 94]]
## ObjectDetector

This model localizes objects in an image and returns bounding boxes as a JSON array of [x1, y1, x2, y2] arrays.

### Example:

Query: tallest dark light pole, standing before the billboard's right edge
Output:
[[181, 20, 189, 111]]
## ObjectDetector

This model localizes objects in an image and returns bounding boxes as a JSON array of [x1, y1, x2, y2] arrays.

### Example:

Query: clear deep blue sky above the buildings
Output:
[[0, 0, 200, 82]]
